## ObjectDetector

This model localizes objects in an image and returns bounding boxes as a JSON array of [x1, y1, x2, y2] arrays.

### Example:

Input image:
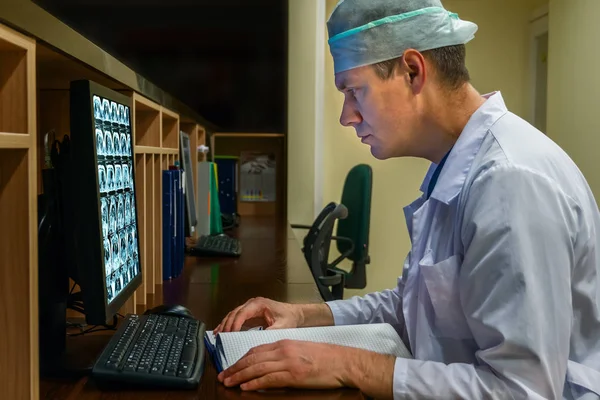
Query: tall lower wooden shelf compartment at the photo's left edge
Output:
[[0, 149, 38, 399]]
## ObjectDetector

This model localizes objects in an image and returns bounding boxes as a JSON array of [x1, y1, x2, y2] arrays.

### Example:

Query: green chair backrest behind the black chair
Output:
[[336, 164, 373, 262]]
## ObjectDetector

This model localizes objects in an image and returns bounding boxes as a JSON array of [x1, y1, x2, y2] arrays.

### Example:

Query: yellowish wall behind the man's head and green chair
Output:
[[322, 0, 552, 297]]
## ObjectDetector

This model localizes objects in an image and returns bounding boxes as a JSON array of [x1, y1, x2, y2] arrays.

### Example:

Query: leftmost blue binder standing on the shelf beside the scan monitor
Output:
[[162, 171, 175, 281]]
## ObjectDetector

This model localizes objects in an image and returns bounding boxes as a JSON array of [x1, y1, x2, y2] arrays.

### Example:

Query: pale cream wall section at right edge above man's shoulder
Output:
[[547, 0, 600, 199]]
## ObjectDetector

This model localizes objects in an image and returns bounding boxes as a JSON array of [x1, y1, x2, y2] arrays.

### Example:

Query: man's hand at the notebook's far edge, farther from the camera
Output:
[[213, 297, 303, 335]]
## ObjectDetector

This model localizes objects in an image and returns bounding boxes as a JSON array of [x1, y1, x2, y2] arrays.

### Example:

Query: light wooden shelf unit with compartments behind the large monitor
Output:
[[0, 14, 214, 400]]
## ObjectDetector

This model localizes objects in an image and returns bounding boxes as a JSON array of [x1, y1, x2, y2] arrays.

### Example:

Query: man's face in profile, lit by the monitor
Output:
[[335, 66, 420, 160]]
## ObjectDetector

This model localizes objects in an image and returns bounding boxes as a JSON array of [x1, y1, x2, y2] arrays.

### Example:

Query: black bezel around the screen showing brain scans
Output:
[[71, 80, 144, 324]]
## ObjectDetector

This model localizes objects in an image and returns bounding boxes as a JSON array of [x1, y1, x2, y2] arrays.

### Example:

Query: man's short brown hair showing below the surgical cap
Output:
[[373, 44, 471, 90]]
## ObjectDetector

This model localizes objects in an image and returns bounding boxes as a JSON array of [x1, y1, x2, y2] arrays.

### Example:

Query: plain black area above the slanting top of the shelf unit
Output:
[[35, 0, 287, 133]]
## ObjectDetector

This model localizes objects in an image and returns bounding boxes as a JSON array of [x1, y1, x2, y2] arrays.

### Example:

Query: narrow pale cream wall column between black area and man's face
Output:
[[287, 0, 325, 235]]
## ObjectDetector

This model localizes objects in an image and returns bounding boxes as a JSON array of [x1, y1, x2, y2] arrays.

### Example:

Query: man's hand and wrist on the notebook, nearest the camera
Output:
[[218, 340, 395, 398]]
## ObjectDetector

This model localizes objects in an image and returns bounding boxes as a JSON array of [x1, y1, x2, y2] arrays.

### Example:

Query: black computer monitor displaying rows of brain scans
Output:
[[70, 80, 142, 325]]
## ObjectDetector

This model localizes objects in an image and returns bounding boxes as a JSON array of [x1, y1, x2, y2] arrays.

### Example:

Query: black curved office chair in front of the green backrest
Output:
[[302, 202, 348, 301]]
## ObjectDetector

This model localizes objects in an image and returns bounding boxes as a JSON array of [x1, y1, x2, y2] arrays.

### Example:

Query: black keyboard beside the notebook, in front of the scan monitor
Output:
[[92, 314, 206, 389]]
